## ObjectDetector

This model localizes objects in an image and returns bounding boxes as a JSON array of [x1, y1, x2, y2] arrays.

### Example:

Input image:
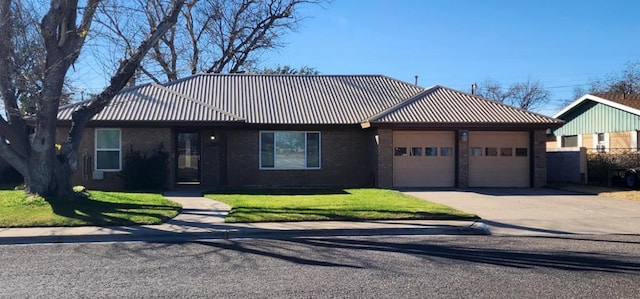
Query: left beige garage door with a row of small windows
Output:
[[393, 131, 455, 187]]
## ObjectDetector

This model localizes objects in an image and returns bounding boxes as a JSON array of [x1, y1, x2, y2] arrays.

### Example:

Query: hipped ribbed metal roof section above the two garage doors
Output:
[[368, 86, 561, 124]]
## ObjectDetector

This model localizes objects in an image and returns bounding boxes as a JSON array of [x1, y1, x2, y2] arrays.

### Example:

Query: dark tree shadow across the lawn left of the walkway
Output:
[[45, 198, 181, 226]]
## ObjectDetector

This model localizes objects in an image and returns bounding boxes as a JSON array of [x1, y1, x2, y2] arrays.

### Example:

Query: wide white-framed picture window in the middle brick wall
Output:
[[260, 131, 320, 169]]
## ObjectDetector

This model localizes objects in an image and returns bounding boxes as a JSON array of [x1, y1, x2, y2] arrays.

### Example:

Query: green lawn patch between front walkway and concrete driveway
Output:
[[205, 189, 478, 222]]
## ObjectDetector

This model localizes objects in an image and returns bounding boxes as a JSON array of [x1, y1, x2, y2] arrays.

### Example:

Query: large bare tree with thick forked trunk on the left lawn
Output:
[[0, 0, 184, 198]]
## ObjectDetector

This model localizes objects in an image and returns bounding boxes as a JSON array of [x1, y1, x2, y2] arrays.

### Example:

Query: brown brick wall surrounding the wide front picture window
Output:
[[225, 128, 373, 187]]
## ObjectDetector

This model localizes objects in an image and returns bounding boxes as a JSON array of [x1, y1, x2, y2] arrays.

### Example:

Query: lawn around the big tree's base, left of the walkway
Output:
[[0, 190, 182, 227]]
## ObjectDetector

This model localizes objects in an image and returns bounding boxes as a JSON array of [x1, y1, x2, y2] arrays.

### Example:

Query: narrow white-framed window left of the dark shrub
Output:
[[96, 129, 122, 171]]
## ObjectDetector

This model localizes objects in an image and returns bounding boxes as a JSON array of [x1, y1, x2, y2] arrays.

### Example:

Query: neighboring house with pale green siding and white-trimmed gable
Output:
[[547, 94, 640, 153]]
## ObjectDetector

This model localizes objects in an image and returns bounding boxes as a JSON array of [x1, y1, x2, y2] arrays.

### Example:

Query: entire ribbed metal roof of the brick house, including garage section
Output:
[[58, 74, 558, 124]]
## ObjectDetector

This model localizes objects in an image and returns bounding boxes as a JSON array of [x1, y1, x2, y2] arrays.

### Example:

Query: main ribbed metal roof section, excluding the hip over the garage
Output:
[[58, 74, 424, 124]]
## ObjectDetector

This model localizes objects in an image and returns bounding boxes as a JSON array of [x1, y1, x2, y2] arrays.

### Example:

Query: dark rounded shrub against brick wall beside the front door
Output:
[[122, 143, 169, 190]]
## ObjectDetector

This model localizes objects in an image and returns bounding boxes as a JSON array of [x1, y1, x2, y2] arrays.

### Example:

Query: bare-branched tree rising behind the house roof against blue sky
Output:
[[97, 0, 326, 82]]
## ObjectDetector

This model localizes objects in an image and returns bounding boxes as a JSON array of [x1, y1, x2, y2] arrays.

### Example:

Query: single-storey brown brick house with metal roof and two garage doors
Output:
[[58, 74, 561, 189]]
